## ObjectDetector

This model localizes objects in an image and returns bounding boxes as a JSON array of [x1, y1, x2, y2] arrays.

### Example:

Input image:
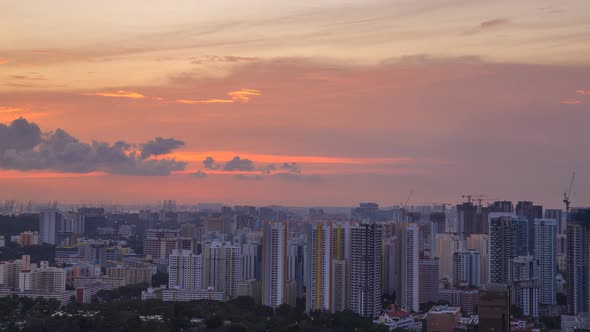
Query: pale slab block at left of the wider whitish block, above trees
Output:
[[168, 250, 203, 289]]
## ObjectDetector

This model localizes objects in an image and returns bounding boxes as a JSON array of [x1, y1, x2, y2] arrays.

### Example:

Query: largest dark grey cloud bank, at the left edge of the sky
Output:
[[0, 119, 186, 176]]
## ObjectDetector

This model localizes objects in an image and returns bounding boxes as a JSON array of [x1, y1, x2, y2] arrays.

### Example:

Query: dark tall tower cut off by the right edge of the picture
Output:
[[566, 208, 590, 315]]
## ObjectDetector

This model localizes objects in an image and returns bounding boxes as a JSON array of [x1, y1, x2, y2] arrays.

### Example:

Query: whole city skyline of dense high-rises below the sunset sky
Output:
[[0, 198, 590, 331]]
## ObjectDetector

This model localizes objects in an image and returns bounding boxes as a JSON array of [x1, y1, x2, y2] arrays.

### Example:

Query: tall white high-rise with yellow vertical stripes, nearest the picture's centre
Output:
[[305, 222, 332, 312]]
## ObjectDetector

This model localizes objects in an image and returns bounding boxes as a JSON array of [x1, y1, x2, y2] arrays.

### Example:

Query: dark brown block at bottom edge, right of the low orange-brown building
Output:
[[478, 282, 510, 332]]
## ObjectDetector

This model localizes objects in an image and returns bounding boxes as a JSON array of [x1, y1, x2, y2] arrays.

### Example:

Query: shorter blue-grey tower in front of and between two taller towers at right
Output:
[[510, 256, 539, 317]]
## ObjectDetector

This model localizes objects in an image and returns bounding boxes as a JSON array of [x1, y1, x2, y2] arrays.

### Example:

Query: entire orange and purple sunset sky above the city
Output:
[[0, 0, 590, 207]]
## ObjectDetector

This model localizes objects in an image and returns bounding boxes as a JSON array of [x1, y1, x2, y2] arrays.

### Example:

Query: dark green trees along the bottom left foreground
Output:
[[0, 294, 385, 332]]
